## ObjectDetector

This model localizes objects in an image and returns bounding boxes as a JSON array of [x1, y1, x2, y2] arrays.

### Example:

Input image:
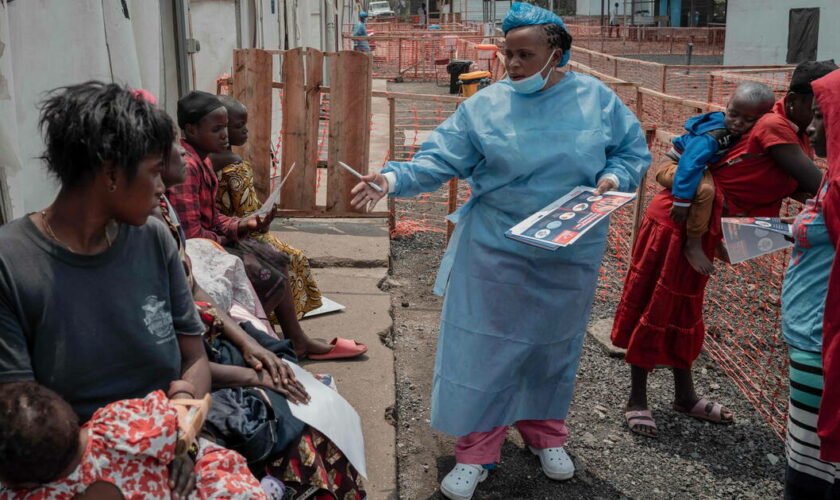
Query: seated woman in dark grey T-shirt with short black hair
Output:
[[0, 82, 246, 496]]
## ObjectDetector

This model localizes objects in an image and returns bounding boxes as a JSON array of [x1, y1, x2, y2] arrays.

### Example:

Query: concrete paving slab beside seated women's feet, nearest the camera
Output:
[[302, 268, 397, 500]]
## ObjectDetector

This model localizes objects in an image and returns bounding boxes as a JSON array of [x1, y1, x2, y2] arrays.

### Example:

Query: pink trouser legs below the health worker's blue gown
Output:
[[455, 420, 569, 465]]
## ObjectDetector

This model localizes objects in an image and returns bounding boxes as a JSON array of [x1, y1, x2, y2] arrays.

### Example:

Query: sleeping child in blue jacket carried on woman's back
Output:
[[656, 82, 775, 274]]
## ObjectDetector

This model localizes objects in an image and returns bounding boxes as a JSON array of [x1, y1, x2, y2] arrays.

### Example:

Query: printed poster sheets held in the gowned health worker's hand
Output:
[[505, 186, 636, 251]]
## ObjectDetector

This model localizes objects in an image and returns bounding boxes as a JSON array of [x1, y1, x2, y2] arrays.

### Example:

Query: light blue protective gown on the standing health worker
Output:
[[383, 72, 650, 436]]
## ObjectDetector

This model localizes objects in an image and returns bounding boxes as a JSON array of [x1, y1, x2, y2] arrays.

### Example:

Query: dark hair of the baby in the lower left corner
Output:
[[0, 381, 79, 485]]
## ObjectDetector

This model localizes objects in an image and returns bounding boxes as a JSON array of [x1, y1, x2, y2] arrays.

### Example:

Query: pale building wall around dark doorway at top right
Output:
[[723, 0, 840, 65]]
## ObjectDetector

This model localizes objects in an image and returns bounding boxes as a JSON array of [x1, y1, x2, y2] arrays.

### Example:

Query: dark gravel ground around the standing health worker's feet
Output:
[[382, 83, 784, 500]]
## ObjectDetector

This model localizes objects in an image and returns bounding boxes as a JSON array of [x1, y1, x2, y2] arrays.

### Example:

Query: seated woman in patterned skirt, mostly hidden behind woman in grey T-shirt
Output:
[[157, 126, 365, 500]]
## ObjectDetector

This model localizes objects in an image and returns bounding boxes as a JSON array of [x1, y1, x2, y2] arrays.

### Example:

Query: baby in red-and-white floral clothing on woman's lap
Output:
[[0, 382, 266, 500]]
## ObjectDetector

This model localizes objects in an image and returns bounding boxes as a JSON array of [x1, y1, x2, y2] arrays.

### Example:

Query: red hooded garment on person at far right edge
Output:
[[811, 71, 840, 462]]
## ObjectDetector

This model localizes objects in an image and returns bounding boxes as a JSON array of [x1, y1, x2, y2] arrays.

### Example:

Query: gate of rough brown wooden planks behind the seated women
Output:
[[231, 48, 380, 217]]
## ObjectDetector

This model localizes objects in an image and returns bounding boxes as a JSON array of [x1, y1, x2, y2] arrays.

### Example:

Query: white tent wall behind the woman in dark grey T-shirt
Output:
[[0, 0, 185, 218]]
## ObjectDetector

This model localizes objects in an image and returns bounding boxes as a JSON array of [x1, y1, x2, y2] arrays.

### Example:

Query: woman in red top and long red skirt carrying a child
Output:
[[612, 62, 836, 437]]
